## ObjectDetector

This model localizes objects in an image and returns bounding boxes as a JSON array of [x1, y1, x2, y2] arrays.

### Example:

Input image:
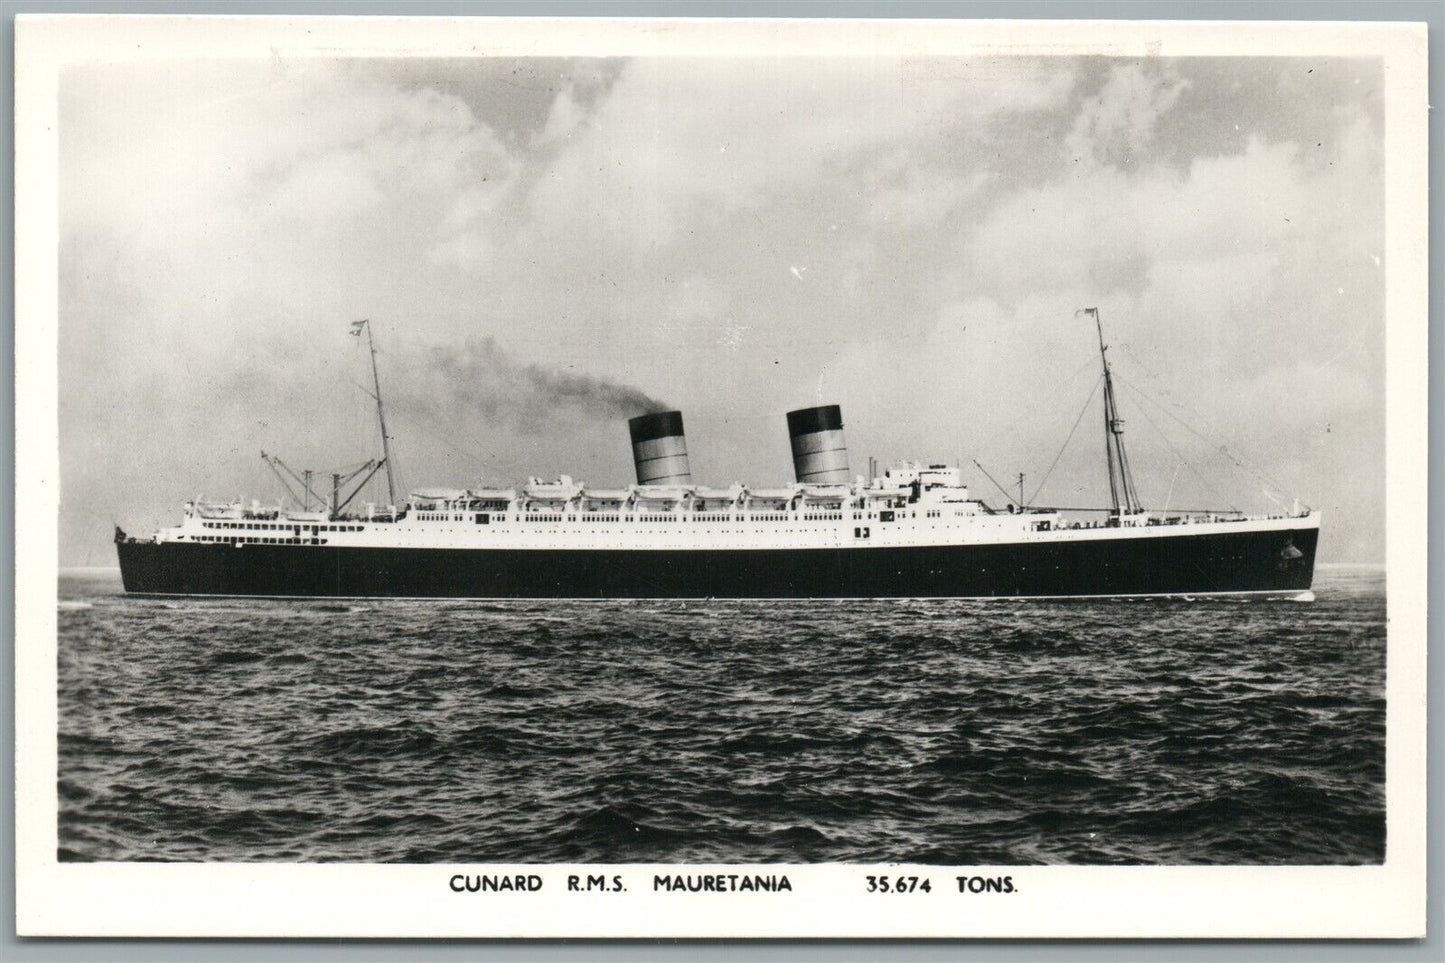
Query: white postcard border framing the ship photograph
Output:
[[14, 16, 1428, 937]]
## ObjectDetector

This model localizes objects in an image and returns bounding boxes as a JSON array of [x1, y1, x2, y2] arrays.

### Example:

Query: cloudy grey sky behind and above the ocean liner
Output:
[[59, 56, 1384, 565]]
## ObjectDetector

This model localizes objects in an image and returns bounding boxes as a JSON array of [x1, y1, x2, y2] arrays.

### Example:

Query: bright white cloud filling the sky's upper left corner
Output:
[[61, 62, 516, 353]]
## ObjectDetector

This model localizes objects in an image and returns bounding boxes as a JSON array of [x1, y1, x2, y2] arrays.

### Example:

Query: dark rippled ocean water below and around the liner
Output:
[[58, 568, 1386, 866]]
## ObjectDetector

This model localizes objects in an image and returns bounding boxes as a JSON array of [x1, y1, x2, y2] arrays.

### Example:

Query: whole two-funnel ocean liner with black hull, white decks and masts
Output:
[[116, 308, 1319, 599]]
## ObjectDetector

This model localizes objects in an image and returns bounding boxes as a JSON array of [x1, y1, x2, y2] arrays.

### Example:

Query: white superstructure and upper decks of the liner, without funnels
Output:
[[155, 463, 1319, 549]]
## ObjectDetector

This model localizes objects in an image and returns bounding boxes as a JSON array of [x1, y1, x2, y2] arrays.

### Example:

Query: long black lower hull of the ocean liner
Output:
[[117, 528, 1319, 599]]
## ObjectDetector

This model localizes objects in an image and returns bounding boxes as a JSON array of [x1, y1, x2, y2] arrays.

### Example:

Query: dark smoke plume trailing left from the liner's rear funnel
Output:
[[389, 337, 668, 429]]
